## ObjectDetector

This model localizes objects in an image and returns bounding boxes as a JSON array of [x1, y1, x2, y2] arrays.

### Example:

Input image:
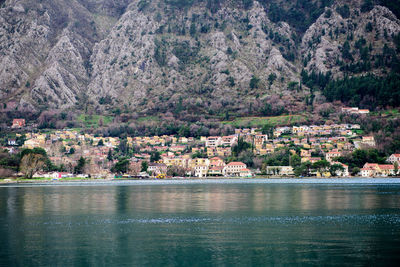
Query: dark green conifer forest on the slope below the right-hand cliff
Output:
[[301, 31, 400, 110]]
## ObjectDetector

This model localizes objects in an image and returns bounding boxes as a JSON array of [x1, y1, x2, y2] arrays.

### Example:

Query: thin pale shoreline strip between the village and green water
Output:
[[0, 177, 400, 187]]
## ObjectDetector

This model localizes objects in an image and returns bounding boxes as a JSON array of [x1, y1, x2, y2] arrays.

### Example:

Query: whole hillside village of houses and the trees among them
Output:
[[2, 120, 400, 178]]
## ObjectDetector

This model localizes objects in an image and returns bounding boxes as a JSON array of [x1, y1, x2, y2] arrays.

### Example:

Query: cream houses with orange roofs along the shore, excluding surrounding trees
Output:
[[1, 120, 400, 177]]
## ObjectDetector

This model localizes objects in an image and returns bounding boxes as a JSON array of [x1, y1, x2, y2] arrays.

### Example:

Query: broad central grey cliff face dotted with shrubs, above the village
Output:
[[89, 1, 298, 115]]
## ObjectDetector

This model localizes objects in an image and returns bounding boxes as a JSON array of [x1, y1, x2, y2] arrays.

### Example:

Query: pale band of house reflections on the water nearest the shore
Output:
[[0, 185, 399, 215]]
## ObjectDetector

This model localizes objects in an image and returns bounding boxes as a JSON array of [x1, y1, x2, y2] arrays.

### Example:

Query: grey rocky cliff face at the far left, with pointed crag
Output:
[[0, 0, 127, 109]]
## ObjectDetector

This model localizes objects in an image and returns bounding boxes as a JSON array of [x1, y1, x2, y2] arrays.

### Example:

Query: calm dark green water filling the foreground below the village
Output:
[[0, 182, 400, 266]]
